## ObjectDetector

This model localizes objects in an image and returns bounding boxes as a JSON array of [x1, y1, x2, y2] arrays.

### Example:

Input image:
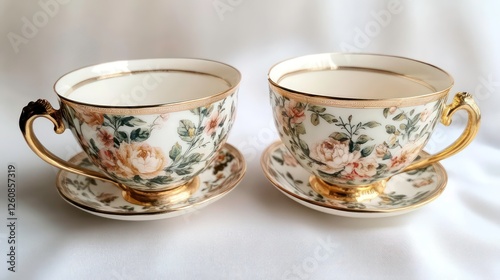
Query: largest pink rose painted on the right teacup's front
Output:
[[311, 138, 361, 174]]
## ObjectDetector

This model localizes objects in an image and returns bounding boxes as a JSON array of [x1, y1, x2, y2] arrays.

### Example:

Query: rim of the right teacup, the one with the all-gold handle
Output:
[[268, 52, 454, 108]]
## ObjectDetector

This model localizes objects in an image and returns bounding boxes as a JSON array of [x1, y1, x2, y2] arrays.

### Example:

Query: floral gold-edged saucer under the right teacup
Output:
[[261, 141, 448, 218]]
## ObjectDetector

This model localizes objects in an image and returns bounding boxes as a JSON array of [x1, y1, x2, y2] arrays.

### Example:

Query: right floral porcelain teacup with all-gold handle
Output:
[[269, 53, 480, 201]]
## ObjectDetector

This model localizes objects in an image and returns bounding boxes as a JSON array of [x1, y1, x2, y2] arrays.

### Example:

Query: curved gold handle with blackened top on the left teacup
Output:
[[19, 99, 115, 183]]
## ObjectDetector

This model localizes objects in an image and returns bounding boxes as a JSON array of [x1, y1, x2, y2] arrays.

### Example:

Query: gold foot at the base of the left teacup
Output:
[[117, 176, 200, 206]]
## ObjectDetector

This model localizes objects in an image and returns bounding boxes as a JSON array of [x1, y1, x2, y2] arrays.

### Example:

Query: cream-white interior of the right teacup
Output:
[[269, 53, 453, 100]]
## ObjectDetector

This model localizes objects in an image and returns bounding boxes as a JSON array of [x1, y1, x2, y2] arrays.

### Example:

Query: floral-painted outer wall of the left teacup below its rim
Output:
[[63, 95, 236, 190]]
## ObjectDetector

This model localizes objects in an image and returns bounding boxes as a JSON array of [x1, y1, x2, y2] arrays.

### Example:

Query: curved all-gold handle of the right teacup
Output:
[[402, 92, 481, 172]]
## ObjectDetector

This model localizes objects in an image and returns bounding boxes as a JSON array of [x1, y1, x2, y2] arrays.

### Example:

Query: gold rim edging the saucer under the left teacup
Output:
[[56, 143, 247, 217]]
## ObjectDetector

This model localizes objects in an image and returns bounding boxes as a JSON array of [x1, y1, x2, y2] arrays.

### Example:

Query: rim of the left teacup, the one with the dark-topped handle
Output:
[[52, 57, 242, 114]]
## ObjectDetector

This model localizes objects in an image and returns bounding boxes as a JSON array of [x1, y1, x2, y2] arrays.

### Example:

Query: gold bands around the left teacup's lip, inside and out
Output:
[[53, 58, 241, 115]]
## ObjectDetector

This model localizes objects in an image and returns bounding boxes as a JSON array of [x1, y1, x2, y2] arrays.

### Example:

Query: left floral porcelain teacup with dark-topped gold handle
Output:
[[20, 58, 241, 205]]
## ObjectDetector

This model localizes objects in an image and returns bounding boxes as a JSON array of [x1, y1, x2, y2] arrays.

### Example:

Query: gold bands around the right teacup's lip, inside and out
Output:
[[268, 53, 454, 108]]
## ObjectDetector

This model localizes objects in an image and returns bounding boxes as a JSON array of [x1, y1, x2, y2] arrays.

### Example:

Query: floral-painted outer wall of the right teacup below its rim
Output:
[[270, 91, 443, 185]]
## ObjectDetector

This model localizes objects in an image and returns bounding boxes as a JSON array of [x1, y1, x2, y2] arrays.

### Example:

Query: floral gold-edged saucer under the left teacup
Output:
[[57, 144, 246, 221]]
